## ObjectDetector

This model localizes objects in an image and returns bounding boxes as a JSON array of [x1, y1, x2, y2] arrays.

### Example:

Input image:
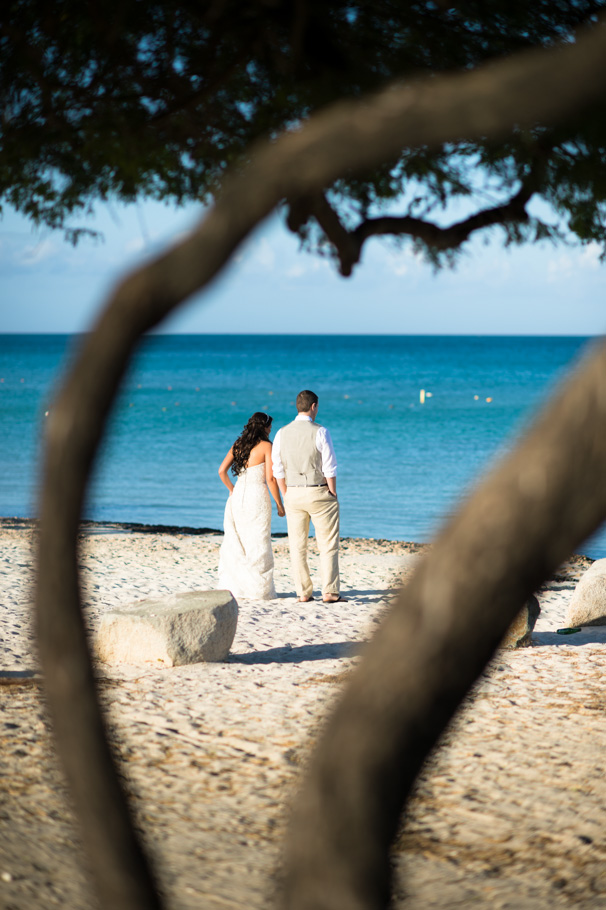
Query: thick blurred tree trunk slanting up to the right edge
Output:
[[284, 343, 606, 910]]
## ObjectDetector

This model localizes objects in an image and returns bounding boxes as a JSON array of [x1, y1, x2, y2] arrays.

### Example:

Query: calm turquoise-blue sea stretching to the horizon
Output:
[[0, 335, 606, 557]]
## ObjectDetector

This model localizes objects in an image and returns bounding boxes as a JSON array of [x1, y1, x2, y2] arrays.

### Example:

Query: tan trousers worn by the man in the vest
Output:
[[284, 487, 339, 597]]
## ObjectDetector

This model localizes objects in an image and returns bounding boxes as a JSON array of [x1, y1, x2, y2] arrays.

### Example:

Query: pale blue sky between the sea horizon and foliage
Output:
[[0, 203, 606, 335]]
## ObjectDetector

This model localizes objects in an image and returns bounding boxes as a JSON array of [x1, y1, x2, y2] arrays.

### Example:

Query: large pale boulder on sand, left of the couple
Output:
[[95, 591, 238, 667]]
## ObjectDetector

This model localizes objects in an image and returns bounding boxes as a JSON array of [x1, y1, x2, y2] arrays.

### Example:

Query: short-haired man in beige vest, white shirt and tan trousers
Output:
[[272, 390, 345, 603]]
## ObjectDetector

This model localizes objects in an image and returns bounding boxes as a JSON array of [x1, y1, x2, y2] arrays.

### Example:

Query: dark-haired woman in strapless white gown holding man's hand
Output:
[[218, 411, 284, 600]]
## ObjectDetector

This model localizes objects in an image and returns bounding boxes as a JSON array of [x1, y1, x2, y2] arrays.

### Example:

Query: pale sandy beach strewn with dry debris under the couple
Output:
[[0, 520, 606, 910]]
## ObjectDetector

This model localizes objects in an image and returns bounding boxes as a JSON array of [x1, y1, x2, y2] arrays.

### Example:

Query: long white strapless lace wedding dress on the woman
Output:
[[218, 462, 277, 600]]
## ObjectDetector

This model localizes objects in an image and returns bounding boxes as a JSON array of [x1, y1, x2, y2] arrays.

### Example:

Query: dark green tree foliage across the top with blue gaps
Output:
[[0, 0, 606, 264]]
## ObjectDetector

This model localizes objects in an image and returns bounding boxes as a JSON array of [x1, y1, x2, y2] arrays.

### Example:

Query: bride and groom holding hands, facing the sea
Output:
[[219, 390, 344, 603]]
